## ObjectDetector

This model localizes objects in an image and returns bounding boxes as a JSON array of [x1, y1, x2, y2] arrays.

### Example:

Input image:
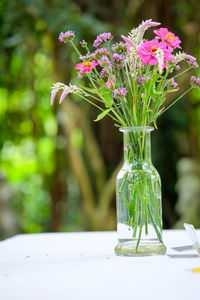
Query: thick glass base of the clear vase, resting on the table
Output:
[[115, 242, 167, 256]]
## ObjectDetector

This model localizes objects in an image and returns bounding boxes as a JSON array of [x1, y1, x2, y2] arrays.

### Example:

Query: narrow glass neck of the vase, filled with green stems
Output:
[[123, 130, 151, 164]]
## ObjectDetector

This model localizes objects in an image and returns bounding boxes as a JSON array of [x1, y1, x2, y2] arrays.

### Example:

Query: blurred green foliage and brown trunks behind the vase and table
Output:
[[0, 0, 200, 239]]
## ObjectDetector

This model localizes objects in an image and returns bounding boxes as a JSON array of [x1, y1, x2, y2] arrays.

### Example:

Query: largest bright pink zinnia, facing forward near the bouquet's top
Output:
[[137, 40, 171, 67]]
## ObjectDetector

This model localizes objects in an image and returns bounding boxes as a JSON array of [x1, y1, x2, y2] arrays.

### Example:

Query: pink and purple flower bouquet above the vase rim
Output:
[[51, 20, 200, 127]]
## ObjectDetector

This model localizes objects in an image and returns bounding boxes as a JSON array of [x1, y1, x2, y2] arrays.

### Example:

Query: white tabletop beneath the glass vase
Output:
[[0, 230, 200, 300]]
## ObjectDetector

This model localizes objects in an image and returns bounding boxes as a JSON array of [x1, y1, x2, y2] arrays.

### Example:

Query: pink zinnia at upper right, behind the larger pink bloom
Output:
[[153, 28, 181, 51]]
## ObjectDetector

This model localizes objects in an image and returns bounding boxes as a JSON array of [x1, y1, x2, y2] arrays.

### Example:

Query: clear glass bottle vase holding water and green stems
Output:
[[115, 126, 166, 256]]
